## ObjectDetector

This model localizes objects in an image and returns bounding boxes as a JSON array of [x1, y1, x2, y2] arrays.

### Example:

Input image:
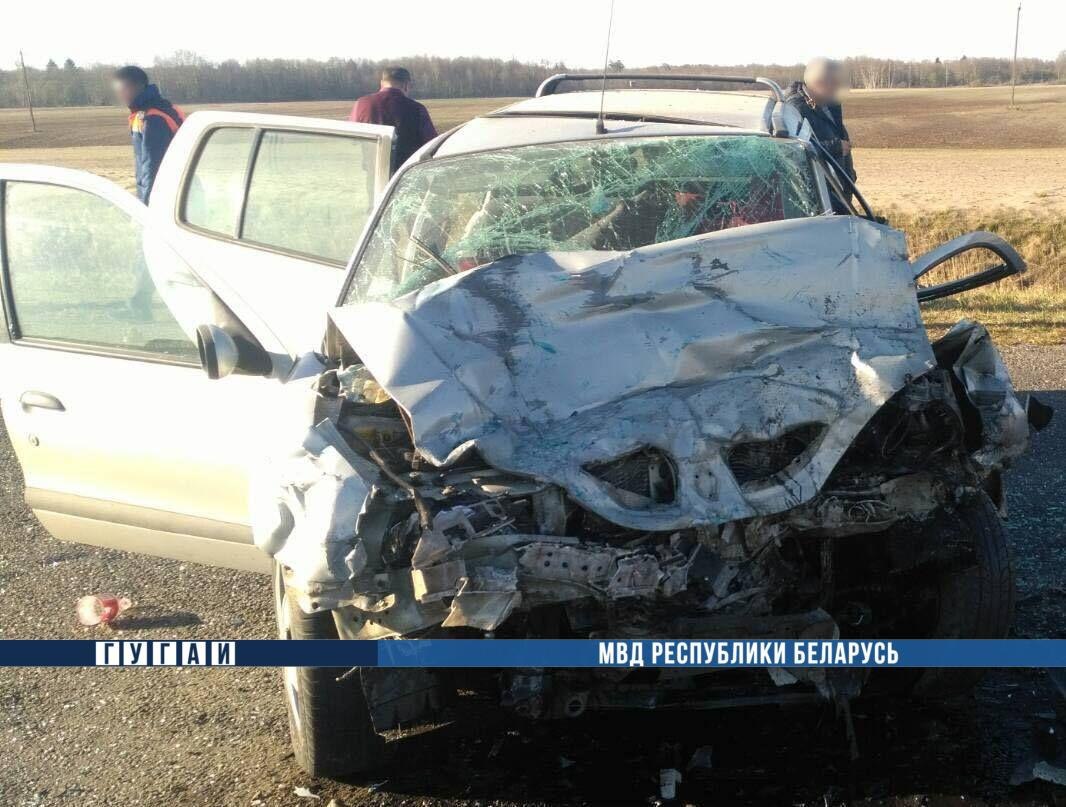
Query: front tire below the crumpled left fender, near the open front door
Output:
[[274, 563, 385, 778]]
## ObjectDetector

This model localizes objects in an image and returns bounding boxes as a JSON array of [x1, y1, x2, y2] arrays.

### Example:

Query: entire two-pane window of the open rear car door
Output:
[[182, 127, 378, 264]]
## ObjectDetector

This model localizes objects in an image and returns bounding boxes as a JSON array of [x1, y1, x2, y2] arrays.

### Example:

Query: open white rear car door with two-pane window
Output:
[[149, 112, 392, 355]]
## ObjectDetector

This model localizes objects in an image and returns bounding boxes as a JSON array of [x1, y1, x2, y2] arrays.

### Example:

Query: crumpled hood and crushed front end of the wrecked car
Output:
[[254, 217, 1050, 730]]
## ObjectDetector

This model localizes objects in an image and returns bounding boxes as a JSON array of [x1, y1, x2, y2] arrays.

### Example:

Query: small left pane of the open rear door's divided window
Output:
[[184, 127, 255, 238]]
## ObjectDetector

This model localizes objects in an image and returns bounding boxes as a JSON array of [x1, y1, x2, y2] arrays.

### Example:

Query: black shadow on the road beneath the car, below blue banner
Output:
[[324, 669, 1054, 805]]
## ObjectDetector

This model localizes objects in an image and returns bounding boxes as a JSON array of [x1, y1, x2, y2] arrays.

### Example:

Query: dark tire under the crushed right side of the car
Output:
[[912, 493, 1015, 698]]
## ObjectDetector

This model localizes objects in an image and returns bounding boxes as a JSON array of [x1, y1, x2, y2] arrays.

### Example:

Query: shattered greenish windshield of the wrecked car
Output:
[[345, 135, 823, 303]]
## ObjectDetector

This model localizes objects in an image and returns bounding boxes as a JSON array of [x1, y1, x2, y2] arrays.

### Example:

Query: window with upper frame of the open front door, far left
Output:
[[2, 181, 201, 365]]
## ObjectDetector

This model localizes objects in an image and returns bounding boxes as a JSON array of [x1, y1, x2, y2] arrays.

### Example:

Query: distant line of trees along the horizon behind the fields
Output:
[[0, 50, 1066, 107]]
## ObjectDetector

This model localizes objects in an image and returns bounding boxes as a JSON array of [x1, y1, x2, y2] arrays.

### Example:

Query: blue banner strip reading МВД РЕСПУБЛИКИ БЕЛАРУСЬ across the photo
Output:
[[0, 639, 1066, 669]]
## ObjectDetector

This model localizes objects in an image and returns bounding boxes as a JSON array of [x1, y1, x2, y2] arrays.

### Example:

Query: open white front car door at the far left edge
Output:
[[0, 164, 309, 570]]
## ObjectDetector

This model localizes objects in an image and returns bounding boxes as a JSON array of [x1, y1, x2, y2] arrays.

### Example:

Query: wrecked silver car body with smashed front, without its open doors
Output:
[[4, 76, 1050, 774]]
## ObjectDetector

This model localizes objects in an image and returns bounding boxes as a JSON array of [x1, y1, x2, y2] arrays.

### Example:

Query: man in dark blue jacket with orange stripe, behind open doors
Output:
[[114, 65, 184, 205]]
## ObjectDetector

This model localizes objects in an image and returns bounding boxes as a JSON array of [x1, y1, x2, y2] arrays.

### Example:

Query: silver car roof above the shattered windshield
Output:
[[430, 90, 802, 158]]
